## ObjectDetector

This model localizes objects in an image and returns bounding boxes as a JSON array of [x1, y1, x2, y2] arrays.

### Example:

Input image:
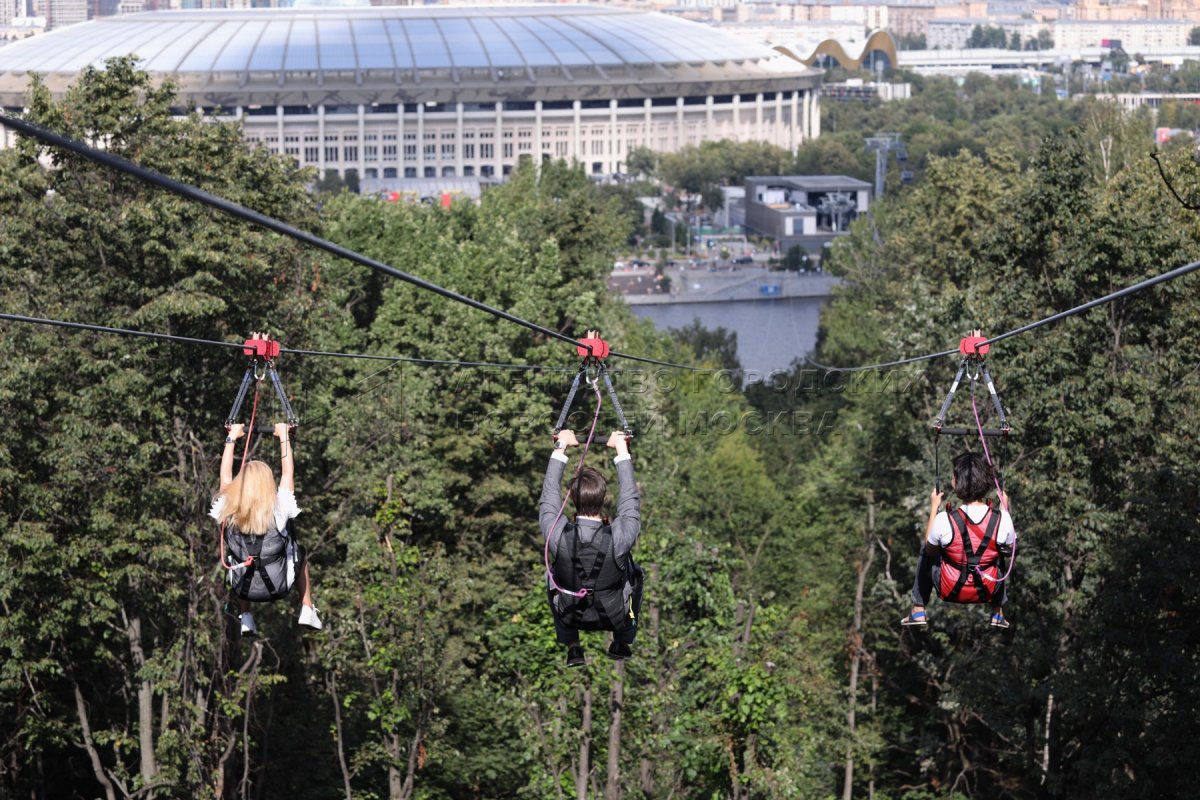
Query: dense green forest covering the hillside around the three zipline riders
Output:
[[0, 61, 1200, 800]]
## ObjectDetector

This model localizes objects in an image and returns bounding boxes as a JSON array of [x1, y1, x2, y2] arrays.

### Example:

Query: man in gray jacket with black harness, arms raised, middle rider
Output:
[[539, 431, 642, 667]]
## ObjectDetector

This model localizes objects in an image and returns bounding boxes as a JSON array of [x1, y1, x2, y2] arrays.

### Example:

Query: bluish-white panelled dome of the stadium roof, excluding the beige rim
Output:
[[0, 5, 772, 80]]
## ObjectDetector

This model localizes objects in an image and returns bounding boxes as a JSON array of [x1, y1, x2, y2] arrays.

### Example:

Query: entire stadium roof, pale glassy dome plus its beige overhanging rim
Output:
[[0, 5, 817, 108]]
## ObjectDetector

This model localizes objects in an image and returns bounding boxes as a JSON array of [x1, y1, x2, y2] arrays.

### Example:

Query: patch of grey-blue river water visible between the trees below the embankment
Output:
[[631, 297, 828, 383]]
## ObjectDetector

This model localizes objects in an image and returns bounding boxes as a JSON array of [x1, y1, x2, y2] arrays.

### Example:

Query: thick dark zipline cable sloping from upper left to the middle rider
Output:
[[0, 113, 698, 369]]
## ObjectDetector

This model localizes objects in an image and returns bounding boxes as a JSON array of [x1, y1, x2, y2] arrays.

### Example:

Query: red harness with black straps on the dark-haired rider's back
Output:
[[937, 503, 1001, 603]]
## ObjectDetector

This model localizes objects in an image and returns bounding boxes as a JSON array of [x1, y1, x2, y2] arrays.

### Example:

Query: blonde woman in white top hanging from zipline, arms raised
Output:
[[209, 422, 322, 636]]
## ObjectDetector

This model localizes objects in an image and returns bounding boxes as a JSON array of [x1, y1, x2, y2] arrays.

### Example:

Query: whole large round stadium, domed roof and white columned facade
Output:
[[0, 5, 821, 179]]
